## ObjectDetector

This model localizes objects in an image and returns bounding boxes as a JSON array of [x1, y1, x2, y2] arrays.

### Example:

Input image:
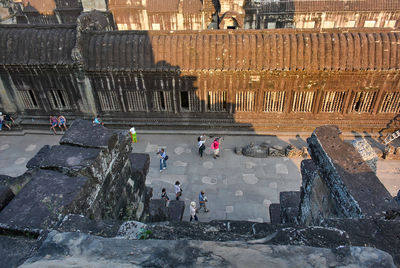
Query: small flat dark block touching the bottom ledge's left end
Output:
[[54, 214, 122, 237]]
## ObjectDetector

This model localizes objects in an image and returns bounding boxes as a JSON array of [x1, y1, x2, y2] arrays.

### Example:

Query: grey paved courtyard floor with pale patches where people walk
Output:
[[0, 132, 400, 222]]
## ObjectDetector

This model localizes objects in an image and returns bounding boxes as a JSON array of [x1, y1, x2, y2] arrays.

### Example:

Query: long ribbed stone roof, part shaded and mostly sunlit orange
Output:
[[83, 29, 400, 71]]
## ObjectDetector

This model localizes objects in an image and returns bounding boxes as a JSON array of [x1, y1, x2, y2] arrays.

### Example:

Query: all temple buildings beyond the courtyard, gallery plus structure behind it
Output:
[[0, 0, 400, 132]]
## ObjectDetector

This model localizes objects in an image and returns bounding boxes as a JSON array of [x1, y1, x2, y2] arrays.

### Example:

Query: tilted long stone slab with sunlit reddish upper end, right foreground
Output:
[[307, 126, 399, 218]]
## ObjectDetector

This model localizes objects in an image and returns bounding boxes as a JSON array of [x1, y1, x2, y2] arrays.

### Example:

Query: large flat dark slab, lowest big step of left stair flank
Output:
[[0, 170, 87, 229]]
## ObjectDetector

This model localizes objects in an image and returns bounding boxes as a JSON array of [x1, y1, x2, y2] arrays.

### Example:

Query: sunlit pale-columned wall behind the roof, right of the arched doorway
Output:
[[244, 0, 400, 30]]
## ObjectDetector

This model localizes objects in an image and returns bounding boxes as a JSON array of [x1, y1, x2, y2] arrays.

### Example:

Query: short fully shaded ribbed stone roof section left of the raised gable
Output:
[[0, 25, 76, 65]]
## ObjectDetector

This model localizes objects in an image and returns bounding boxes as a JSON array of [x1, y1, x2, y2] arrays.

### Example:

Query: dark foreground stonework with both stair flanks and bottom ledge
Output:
[[0, 124, 400, 268]]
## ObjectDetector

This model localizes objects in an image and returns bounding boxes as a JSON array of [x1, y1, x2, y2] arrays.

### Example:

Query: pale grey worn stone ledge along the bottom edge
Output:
[[21, 231, 395, 268]]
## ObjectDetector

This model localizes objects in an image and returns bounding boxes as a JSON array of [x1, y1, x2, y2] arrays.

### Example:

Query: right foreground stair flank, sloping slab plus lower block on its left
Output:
[[300, 126, 399, 224]]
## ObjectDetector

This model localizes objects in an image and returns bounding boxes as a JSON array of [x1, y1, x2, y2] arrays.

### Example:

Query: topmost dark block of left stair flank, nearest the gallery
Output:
[[60, 119, 118, 149]]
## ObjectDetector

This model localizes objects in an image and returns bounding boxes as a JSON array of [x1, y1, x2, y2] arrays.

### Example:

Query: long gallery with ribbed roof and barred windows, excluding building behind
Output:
[[0, 20, 400, 132]]
